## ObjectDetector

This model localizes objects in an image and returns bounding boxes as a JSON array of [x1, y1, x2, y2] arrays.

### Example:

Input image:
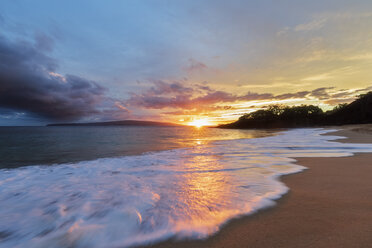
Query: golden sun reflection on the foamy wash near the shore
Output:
[[176, 147, 236, 234]]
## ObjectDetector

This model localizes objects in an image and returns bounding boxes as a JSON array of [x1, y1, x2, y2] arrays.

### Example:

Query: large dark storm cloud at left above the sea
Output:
[[0, 35, 105, 120]]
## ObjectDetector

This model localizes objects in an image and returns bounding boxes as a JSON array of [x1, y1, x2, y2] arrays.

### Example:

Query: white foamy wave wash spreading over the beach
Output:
[[0, 129, 372, 248]]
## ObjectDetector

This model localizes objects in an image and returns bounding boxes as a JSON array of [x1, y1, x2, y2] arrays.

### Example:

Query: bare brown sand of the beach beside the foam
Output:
[[142, 125, 372, 248]]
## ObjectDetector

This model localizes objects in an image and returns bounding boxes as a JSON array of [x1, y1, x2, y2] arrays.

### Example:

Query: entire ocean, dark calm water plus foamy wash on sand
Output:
[[0, 127, 372, 248]]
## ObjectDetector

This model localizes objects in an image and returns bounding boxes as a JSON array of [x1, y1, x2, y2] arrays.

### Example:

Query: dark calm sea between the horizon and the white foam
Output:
[[0, 126, 273, 168]]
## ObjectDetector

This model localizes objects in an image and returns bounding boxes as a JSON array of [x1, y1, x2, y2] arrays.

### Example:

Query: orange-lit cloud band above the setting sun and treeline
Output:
[[124, 81, 370, 117]]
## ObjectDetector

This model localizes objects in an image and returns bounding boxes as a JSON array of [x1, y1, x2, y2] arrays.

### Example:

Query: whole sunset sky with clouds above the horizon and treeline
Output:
[[0, 0, 372, 125]]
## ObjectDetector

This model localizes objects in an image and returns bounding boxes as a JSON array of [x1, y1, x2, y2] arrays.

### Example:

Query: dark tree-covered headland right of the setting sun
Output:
[[218, 91, 372, 129]]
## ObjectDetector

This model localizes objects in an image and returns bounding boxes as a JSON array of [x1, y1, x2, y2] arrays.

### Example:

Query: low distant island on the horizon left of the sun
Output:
[[47, 120, 181, 127]]
